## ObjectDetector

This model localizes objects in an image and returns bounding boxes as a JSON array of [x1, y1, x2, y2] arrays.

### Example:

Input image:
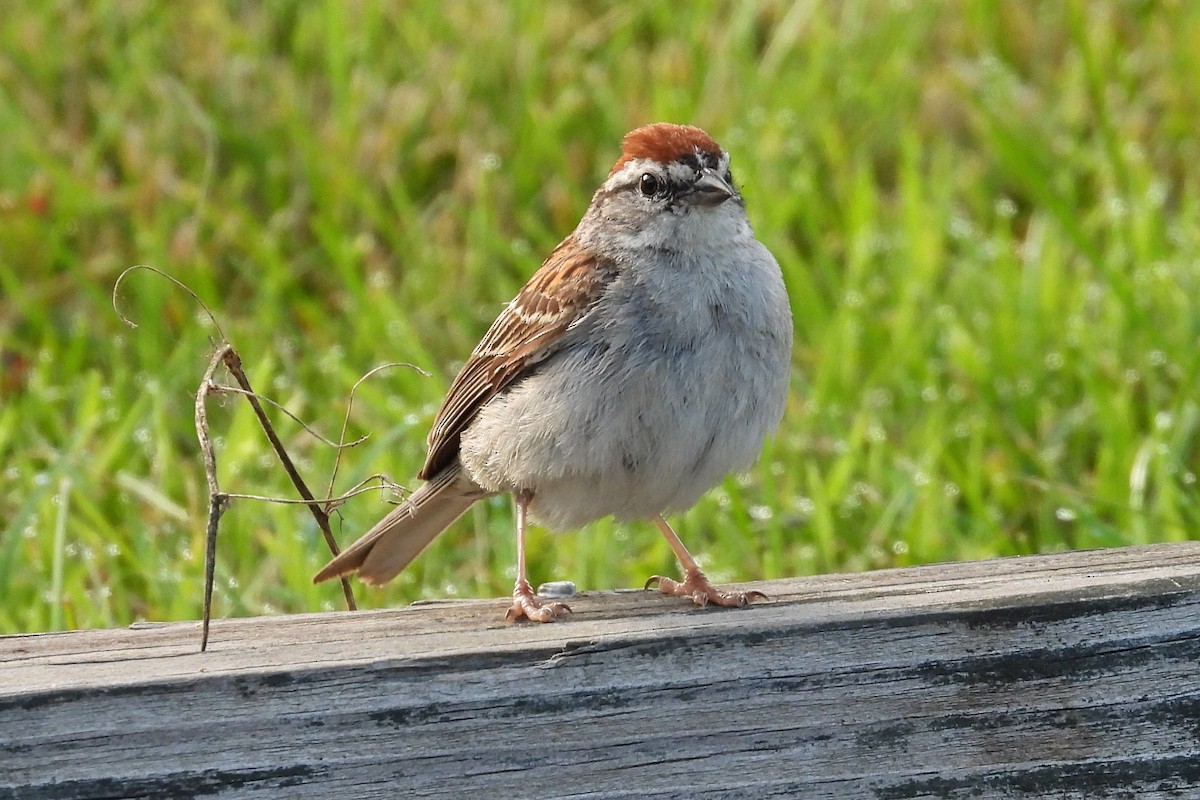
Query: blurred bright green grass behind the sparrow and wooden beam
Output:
[[0, 0, 1200, 632]]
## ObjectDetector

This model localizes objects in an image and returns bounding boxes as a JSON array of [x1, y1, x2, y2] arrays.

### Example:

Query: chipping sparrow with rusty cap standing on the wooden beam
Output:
[[313, 124, 792, 622]]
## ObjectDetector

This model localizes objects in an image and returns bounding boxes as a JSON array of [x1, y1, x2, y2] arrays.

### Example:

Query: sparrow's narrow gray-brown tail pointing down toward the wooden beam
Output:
[[312, 464, 486, 585]]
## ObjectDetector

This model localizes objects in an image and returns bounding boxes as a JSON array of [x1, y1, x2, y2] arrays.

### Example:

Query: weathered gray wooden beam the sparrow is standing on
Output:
[[0, 543, 1200, 800]]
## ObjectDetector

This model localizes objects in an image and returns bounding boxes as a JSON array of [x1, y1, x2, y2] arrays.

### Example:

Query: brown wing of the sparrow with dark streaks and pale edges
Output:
[[418, 236, 617, 481]]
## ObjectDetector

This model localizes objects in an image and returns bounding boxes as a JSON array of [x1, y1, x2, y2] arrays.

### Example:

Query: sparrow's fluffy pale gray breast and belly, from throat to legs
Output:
[[461, 237, 791, 528]]
